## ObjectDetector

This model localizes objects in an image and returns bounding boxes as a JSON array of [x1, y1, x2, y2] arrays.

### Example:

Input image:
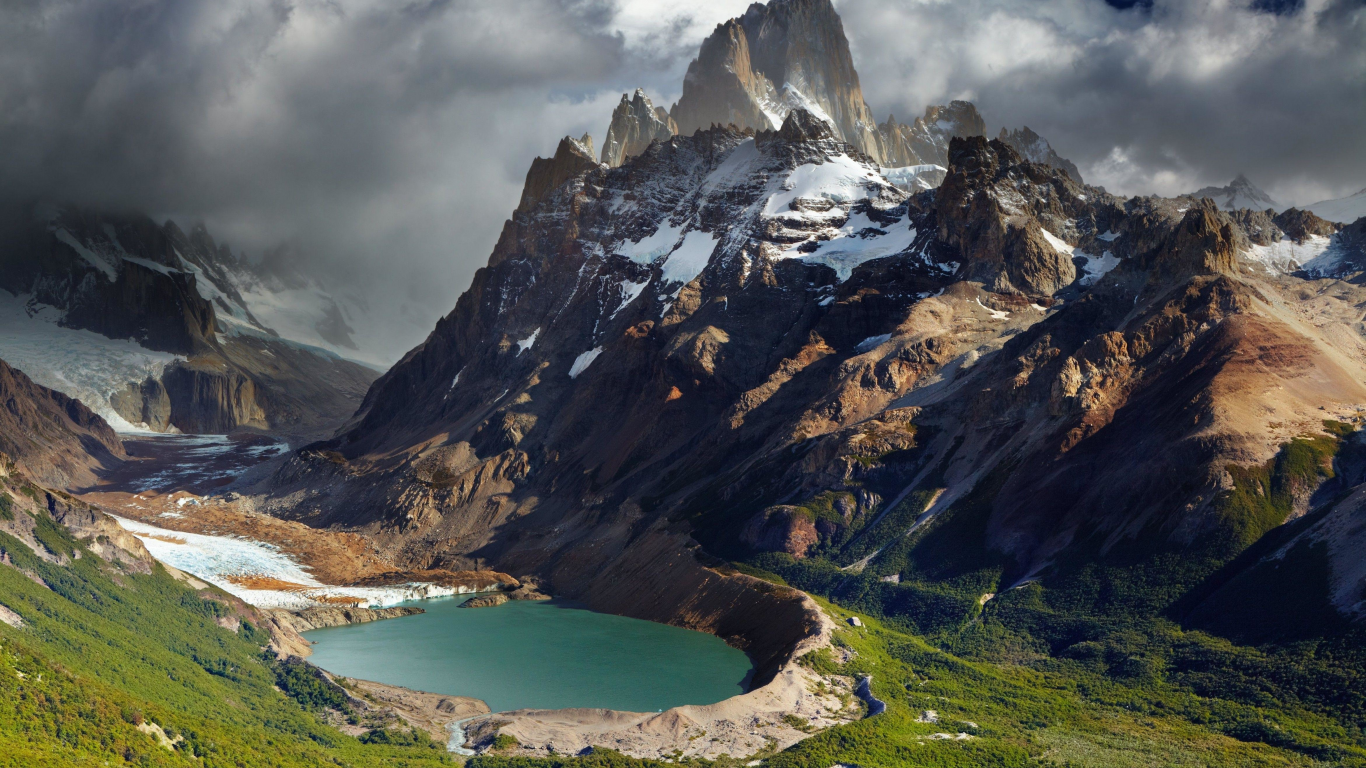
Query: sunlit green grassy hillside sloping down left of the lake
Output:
[[0, 482, 452, 768]]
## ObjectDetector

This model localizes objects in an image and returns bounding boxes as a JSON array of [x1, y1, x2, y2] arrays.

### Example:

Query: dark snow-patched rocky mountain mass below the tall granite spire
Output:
[[266, 98, 1359, 655]]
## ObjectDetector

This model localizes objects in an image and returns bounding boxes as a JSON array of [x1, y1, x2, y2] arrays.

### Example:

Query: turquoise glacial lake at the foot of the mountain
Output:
[[305, 596, 751, 712]]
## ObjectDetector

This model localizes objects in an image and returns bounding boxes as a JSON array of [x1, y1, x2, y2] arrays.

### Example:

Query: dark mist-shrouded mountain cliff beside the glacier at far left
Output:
[[0, 208, 376, 436]]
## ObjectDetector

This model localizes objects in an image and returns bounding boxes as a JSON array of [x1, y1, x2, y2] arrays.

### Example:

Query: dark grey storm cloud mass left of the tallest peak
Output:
[[0, 0, 644, 358]]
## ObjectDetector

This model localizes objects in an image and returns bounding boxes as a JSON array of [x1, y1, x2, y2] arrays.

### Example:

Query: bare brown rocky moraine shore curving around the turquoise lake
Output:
[[99, 434, 858, 758]]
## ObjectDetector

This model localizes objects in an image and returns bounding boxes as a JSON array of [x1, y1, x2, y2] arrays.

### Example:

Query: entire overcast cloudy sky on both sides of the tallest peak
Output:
[[0, 0, 1366, 359]]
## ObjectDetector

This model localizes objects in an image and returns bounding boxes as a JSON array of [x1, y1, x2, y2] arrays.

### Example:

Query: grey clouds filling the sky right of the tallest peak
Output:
[[840, 0, 1366, 204]]
